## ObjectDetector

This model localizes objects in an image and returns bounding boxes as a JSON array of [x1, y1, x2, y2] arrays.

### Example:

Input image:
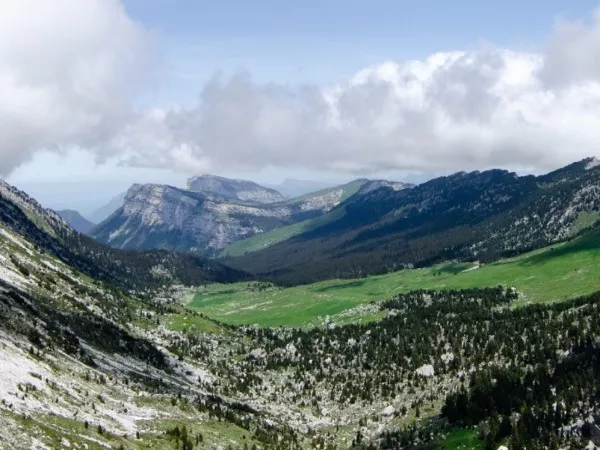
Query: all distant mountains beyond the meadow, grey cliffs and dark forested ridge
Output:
[[52, 158, 600, 284]]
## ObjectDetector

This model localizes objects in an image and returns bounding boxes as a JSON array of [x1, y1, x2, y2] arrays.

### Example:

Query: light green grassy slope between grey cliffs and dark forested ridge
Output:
[[219, 180, 365, 257]]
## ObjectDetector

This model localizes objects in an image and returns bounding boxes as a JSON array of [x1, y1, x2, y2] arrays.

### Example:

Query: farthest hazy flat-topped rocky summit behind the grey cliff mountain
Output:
[[188, 175, 284, 203]]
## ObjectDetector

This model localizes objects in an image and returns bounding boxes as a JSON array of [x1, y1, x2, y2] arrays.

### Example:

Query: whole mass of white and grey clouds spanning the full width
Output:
[[0, 0, 600, 174]]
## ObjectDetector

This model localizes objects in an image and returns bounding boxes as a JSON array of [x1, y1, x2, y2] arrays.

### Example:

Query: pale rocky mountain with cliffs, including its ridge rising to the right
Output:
[[92, 180, 376, 256]]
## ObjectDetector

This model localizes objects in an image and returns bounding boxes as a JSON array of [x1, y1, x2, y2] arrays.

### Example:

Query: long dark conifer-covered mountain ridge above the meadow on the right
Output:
[[226, 158, 600, 284]]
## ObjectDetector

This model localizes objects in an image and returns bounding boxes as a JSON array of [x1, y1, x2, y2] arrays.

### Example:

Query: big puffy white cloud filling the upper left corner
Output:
[[0, 0, 152, 175]]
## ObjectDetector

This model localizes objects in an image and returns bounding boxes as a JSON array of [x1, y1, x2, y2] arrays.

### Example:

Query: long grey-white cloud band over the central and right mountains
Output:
[[114, 43, 600, 173]]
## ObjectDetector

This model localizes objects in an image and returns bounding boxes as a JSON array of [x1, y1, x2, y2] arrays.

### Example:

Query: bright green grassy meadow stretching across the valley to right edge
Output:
[[188, 231, 600, 326]]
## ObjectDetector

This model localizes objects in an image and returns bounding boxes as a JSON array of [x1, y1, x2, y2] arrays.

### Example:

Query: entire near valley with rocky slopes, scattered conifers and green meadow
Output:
[[0, 178, 600, 450]]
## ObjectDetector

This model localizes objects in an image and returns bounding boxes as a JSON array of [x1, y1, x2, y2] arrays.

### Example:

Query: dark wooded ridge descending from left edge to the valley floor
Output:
[[0, 180, 246, 292]]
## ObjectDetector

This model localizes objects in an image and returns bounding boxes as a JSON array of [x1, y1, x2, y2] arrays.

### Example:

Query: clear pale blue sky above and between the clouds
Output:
[[125, 0, 598, 104]]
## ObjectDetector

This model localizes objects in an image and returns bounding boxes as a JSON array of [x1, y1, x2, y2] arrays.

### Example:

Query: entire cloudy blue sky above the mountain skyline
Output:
[[0, 0, 600, 213]]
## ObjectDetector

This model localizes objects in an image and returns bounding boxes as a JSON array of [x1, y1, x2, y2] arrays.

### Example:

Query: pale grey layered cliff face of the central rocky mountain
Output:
[[94, 184, 288, 254]]
